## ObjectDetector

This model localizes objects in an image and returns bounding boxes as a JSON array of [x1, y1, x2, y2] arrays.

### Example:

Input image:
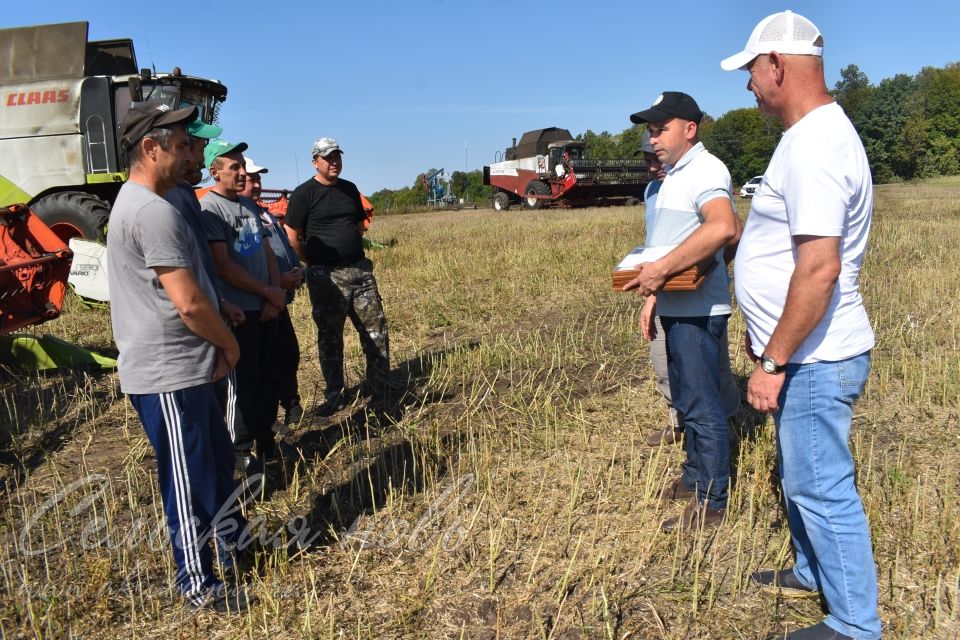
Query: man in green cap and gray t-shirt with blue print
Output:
[[200, 139, 287, 474]]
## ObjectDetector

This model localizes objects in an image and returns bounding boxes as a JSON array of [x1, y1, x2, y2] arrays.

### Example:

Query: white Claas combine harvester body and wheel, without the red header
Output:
[[0, 22, 227, 301]]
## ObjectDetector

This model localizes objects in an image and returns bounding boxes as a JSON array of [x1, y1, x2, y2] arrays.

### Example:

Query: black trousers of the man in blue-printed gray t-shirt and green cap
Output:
[[219, 310, 278, 457]]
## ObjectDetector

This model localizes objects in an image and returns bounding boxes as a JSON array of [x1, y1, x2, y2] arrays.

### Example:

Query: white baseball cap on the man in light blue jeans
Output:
[[720, 11, 823, 71]]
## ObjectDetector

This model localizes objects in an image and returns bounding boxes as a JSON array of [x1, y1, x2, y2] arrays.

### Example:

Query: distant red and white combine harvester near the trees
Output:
[[483, 127, 650, 211]]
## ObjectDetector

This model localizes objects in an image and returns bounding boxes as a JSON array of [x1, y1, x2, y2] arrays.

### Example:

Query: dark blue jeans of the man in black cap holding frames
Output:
[[660, 316, 730, 509]]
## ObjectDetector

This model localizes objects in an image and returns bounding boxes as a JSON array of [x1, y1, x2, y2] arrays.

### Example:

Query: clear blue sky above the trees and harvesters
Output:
[[4, 0, 960, 193]]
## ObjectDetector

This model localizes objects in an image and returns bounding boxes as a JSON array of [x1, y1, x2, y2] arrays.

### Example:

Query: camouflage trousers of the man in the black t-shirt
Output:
[[307, 258, 390, 401]]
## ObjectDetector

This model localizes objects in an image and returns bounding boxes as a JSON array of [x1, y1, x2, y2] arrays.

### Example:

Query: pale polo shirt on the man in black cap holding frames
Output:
[[647, 142, 733, 317]]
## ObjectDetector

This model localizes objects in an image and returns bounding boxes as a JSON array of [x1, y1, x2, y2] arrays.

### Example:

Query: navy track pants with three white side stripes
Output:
[[130, 384, 246, 604]]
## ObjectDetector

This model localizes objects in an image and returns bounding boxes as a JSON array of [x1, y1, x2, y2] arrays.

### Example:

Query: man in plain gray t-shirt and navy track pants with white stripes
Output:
[[107, 102, 249, 611]]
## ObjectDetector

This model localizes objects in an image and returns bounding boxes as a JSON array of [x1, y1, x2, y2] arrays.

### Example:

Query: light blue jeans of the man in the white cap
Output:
[[773, 352, 880, 639]]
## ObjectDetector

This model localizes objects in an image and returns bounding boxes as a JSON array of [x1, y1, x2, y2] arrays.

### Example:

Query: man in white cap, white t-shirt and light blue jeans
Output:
[[720, 11, 881, 640]]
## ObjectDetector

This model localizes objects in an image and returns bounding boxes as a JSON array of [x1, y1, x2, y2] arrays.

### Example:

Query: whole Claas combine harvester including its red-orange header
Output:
[[0, 22, 227, 364]]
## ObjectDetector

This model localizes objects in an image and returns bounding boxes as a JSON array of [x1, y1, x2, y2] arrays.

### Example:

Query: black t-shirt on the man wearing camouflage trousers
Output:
[[284, 178, 364, 267]]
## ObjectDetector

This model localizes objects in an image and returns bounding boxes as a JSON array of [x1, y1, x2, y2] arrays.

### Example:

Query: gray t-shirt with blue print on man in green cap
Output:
[[200, 191, 270, 311]]
